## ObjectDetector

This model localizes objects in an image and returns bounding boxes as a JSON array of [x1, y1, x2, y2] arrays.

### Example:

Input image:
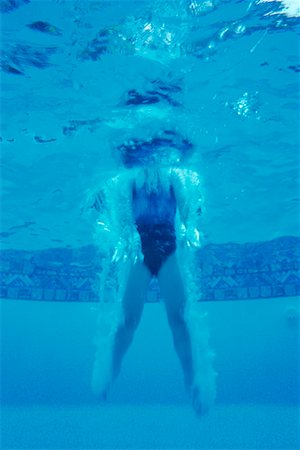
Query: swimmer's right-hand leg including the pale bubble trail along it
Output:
[[158, 254, 216, 415]]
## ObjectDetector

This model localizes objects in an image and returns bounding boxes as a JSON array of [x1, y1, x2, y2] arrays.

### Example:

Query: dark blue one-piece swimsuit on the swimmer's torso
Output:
[[132, 180, 176, 276]]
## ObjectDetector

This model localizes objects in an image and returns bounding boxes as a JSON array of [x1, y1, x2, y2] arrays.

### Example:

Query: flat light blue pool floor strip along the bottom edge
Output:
[[1, 404, 300, 450]]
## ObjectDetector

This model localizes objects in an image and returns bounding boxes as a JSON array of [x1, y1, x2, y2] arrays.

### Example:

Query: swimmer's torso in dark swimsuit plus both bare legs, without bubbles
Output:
[[113, 172, 193, 394]]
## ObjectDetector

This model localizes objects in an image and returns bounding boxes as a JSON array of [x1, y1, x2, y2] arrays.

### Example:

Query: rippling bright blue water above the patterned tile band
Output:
[[1, 0, 299, 249]]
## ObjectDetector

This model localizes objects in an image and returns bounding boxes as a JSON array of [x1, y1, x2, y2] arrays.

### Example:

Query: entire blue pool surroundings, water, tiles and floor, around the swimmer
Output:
[[0, 0, 300, 450]]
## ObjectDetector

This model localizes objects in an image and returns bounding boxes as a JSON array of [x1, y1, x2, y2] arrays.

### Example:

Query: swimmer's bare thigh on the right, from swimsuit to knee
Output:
[[158, 253, 186, 316]]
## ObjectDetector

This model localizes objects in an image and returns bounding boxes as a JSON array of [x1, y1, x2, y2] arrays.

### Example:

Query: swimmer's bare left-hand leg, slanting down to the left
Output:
[[112, 261, 151, 380]]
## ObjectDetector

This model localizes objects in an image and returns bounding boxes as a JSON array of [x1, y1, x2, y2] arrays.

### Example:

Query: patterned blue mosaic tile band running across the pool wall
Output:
[[0, 237, 300, 302]]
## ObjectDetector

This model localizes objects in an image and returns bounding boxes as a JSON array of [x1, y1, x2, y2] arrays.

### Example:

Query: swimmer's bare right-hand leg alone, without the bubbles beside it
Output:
[[158, 254, 193, 390]]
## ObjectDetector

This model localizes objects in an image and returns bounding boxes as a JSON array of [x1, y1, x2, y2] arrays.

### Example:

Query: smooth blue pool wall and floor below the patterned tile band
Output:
[[1, 298, 299, 450]]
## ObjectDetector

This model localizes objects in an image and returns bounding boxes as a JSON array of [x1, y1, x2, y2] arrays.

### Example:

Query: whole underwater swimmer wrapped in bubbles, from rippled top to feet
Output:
[[86, 131, 216, 414]]
